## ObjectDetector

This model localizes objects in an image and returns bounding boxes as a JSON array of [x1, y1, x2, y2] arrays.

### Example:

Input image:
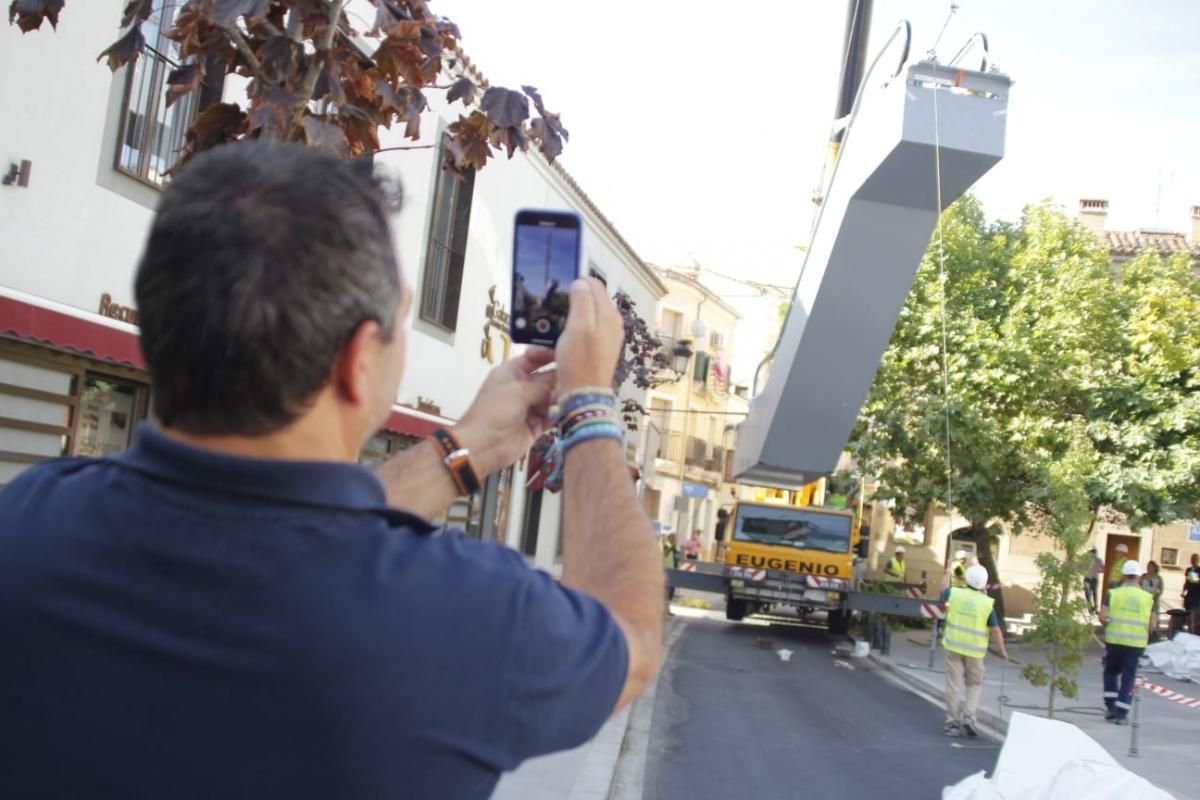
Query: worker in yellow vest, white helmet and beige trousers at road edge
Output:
[[942, 564, 1008, 736]]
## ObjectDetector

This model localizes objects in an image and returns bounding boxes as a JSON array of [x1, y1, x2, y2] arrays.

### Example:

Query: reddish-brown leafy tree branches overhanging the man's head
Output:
[[8, 0, 568, 174]]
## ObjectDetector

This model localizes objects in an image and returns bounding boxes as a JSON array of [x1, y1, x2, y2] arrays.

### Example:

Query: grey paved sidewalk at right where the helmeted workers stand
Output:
[[870, 631, 1200, 800]]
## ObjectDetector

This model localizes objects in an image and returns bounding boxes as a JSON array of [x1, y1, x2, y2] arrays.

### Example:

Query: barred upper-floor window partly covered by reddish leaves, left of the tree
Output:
[[116, 4, 197, 187]]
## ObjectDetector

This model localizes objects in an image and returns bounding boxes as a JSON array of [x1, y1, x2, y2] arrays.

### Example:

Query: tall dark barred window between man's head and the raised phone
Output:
[[421, 144, 475, 331]]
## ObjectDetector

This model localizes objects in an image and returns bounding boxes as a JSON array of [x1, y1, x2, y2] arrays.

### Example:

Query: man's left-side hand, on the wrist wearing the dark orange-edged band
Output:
[[455, 348, 554, 480]]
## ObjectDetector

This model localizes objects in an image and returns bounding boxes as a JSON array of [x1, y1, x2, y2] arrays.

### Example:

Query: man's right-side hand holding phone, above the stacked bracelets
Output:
[[554, 278, 625, 393]]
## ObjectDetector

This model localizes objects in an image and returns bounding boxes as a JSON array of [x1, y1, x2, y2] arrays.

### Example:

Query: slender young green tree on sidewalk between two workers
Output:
[[1021, 419, 1097, 717]]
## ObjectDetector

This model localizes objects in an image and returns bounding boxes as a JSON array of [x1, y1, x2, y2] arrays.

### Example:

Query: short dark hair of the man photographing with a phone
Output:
[[136, 142, 400, 435]]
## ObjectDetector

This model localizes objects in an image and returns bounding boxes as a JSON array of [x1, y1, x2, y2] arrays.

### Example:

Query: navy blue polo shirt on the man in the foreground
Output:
[[0, 426, 628, 800]]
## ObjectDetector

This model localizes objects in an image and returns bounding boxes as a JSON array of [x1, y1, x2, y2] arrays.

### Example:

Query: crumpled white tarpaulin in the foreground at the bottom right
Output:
[[942, 712, 1174, 800]]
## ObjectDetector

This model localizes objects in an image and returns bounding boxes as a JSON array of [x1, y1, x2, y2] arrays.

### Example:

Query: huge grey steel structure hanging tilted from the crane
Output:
[[733, 53, 1012, 488]]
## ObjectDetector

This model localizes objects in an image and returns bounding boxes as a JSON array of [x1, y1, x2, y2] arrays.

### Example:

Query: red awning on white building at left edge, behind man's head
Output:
[[0, 296, 145, 369]]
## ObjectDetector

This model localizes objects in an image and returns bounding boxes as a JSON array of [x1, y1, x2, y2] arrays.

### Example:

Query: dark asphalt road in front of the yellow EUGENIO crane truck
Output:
[[643, 619, 1000, 800]]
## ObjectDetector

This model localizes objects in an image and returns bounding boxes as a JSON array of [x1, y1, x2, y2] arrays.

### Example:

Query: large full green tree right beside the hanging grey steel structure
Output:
[[851, 196, 1116, 613]]
